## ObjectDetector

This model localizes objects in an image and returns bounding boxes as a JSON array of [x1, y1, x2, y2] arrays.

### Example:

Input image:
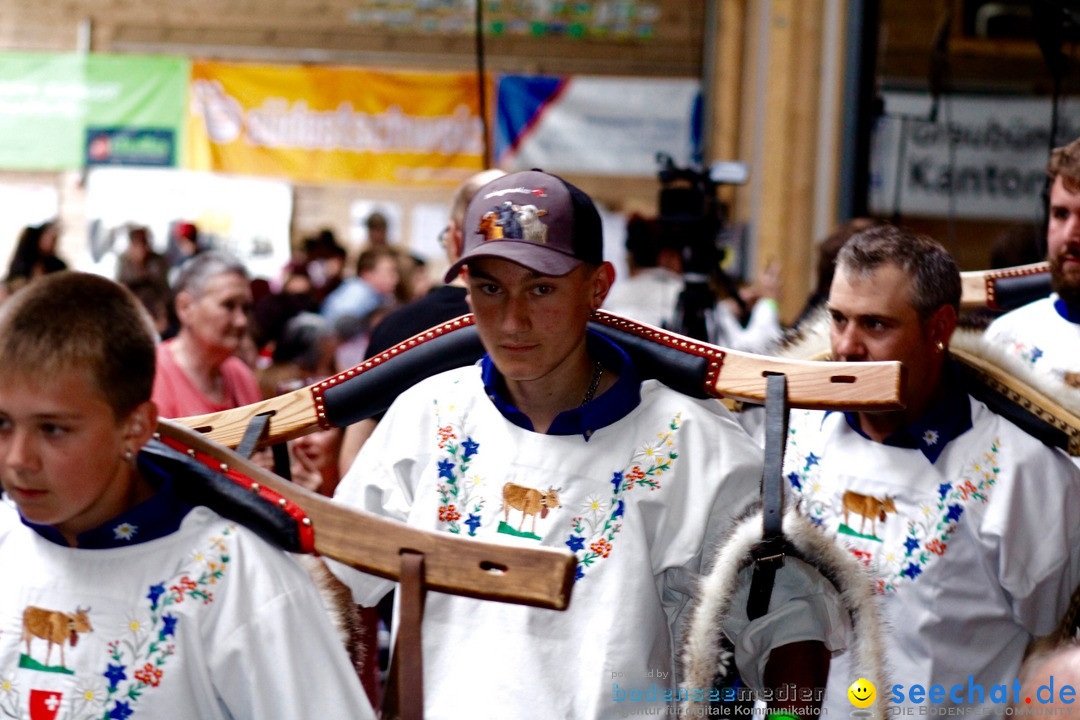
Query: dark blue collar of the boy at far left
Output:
[[21, 453, 192, 549]]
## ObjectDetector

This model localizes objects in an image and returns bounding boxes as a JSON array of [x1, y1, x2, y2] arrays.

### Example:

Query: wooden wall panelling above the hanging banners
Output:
[[0, 0, 705, 77]]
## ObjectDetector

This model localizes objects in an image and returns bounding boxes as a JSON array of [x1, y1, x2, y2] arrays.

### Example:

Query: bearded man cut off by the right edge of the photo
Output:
[[986, 139, 1080, 388]]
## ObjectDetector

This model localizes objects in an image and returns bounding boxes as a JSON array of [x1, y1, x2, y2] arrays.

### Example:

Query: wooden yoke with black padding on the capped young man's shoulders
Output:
[[176, 311, 903, 448]]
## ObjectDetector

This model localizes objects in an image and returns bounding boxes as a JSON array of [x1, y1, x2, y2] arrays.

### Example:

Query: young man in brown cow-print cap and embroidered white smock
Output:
[[336, 171, 761, 719]]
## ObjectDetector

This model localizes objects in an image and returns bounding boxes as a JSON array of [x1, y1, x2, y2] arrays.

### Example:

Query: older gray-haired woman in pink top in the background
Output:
[[152, 250, 262, 418]]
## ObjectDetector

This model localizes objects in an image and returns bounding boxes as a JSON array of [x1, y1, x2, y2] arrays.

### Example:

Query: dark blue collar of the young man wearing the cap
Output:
[[481, 330, 642, 440]]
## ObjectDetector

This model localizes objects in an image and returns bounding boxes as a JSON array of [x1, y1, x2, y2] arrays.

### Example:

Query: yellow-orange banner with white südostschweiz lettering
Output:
[[185, 62, 489, 184]]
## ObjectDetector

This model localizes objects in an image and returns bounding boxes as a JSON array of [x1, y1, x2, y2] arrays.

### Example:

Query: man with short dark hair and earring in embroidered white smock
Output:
[[766, 226, 1080, 712]]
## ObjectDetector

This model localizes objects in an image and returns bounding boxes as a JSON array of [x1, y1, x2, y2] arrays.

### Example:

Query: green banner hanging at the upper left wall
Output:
[[0, 53, 189, 171]]
